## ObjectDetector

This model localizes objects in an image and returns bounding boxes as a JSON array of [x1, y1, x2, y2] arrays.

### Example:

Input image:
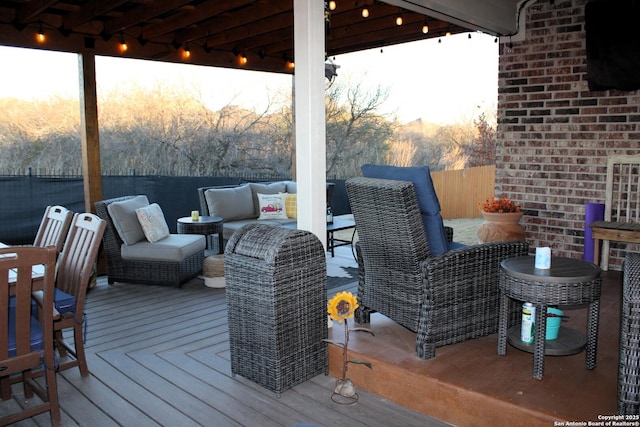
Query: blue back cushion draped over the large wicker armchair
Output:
[[362, 164, 460, 256]]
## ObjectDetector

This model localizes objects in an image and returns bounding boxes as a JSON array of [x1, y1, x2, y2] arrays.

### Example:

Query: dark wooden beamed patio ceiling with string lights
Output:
[[0, 0, 471, 73]]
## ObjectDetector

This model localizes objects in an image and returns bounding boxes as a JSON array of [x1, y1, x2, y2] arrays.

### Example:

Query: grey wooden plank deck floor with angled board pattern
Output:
[[0, 246, 447, 427]]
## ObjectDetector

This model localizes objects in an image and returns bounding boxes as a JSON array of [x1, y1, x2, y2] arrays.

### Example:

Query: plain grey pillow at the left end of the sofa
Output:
[[204, 184, 258, 221]]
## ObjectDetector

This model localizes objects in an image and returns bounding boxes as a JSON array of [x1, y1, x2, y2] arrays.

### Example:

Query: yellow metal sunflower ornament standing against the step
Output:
[[325, 292, 373, 405]]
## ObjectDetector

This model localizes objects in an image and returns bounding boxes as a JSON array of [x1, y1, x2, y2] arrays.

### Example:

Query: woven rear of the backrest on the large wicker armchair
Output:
[[346, 178, 430, 331]]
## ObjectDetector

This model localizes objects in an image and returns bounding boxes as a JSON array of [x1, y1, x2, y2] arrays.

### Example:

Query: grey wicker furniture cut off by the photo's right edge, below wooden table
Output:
[[618, 253, 640, 415]]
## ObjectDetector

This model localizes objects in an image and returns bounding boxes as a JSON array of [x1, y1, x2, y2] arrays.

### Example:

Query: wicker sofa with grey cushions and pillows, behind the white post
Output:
[[198, 181, 335, 241]]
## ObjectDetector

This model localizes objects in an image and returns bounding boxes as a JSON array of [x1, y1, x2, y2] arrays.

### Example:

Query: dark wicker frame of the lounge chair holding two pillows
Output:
[[95, 196, 204, 286]]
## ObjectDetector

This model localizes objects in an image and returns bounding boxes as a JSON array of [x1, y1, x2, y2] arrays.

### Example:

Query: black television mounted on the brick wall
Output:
[[585, 0, 640, 91]]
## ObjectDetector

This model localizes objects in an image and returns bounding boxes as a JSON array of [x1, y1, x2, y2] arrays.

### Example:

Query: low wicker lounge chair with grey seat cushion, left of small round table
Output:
[[95, 196, 206, 286]]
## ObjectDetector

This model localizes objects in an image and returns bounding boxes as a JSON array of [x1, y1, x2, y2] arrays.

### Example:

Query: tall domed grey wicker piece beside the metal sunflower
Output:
[[225, 224, 328, 395]]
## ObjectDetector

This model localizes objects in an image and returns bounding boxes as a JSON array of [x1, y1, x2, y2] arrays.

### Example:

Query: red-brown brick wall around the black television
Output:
[[496, 0, 640, 270]]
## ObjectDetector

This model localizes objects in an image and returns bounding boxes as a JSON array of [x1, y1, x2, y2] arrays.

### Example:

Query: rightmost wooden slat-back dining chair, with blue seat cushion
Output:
[[53, 213, 107, 377]]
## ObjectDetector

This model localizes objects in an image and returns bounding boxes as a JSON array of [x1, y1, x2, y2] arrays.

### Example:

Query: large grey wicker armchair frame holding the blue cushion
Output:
[[346, 177, 529, 359]]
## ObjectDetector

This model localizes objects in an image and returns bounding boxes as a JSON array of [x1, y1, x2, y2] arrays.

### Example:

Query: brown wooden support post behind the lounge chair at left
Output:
[[78, 51, 102, 213]]
